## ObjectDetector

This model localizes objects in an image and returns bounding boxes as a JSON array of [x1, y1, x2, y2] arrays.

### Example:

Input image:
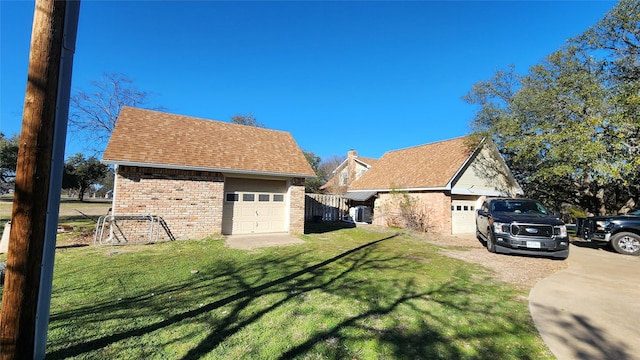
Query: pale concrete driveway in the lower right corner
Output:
[[529, 241, 640, 360]]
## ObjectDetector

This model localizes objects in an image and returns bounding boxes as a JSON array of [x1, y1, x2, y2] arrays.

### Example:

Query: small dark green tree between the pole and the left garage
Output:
[[62, 153, 108, 201]]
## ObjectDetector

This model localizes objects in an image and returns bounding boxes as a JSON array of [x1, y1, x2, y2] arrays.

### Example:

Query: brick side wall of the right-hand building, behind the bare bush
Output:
[[373, 192, 451, 234]]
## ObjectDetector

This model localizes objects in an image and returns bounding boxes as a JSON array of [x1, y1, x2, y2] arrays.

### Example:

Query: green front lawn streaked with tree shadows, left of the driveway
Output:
[[5, 228, 553, 359]]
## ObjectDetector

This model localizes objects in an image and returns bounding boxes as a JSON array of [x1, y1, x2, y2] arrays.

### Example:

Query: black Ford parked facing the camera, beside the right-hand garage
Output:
[[476, 198, 569, 259]]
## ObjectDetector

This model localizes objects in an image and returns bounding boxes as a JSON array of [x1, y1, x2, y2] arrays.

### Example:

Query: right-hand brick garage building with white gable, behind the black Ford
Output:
[[345, 137, 523, 234]]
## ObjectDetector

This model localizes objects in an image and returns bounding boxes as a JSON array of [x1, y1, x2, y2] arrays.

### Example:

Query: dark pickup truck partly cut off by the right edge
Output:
[[576, 210, 640, 256]]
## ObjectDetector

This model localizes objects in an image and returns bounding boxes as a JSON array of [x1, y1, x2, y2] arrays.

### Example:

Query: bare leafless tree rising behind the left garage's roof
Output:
[[69, 73, 159, 153]]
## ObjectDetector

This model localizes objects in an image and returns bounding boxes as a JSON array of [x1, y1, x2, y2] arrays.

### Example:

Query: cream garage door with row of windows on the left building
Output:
[[222, 178, 287, 235]]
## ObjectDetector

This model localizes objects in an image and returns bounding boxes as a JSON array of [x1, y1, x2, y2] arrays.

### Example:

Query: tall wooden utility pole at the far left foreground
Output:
[[0, 0, 79, 359]]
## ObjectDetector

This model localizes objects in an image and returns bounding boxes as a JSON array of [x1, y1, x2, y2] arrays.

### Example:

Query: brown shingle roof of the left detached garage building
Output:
[[103, 107, 315, 177]]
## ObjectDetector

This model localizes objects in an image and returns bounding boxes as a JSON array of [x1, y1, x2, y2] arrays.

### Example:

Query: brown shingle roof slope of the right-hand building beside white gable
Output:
[[349, 137, 475, 191]]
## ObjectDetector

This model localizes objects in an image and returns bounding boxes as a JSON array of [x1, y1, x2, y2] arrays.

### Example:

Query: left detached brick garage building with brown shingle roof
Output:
[[103, 107, 316, 239]]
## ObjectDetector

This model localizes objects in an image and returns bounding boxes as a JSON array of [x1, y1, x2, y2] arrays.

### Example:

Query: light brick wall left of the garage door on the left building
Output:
[[113, 166, 224, 239]]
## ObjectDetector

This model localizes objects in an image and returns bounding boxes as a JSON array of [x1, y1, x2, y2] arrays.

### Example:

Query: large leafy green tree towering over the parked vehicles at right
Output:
[[464, 1, 640, 214]]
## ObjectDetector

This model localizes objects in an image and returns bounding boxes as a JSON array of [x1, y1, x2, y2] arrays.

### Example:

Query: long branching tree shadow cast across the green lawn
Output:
[[47, 234, 560, 359]]
